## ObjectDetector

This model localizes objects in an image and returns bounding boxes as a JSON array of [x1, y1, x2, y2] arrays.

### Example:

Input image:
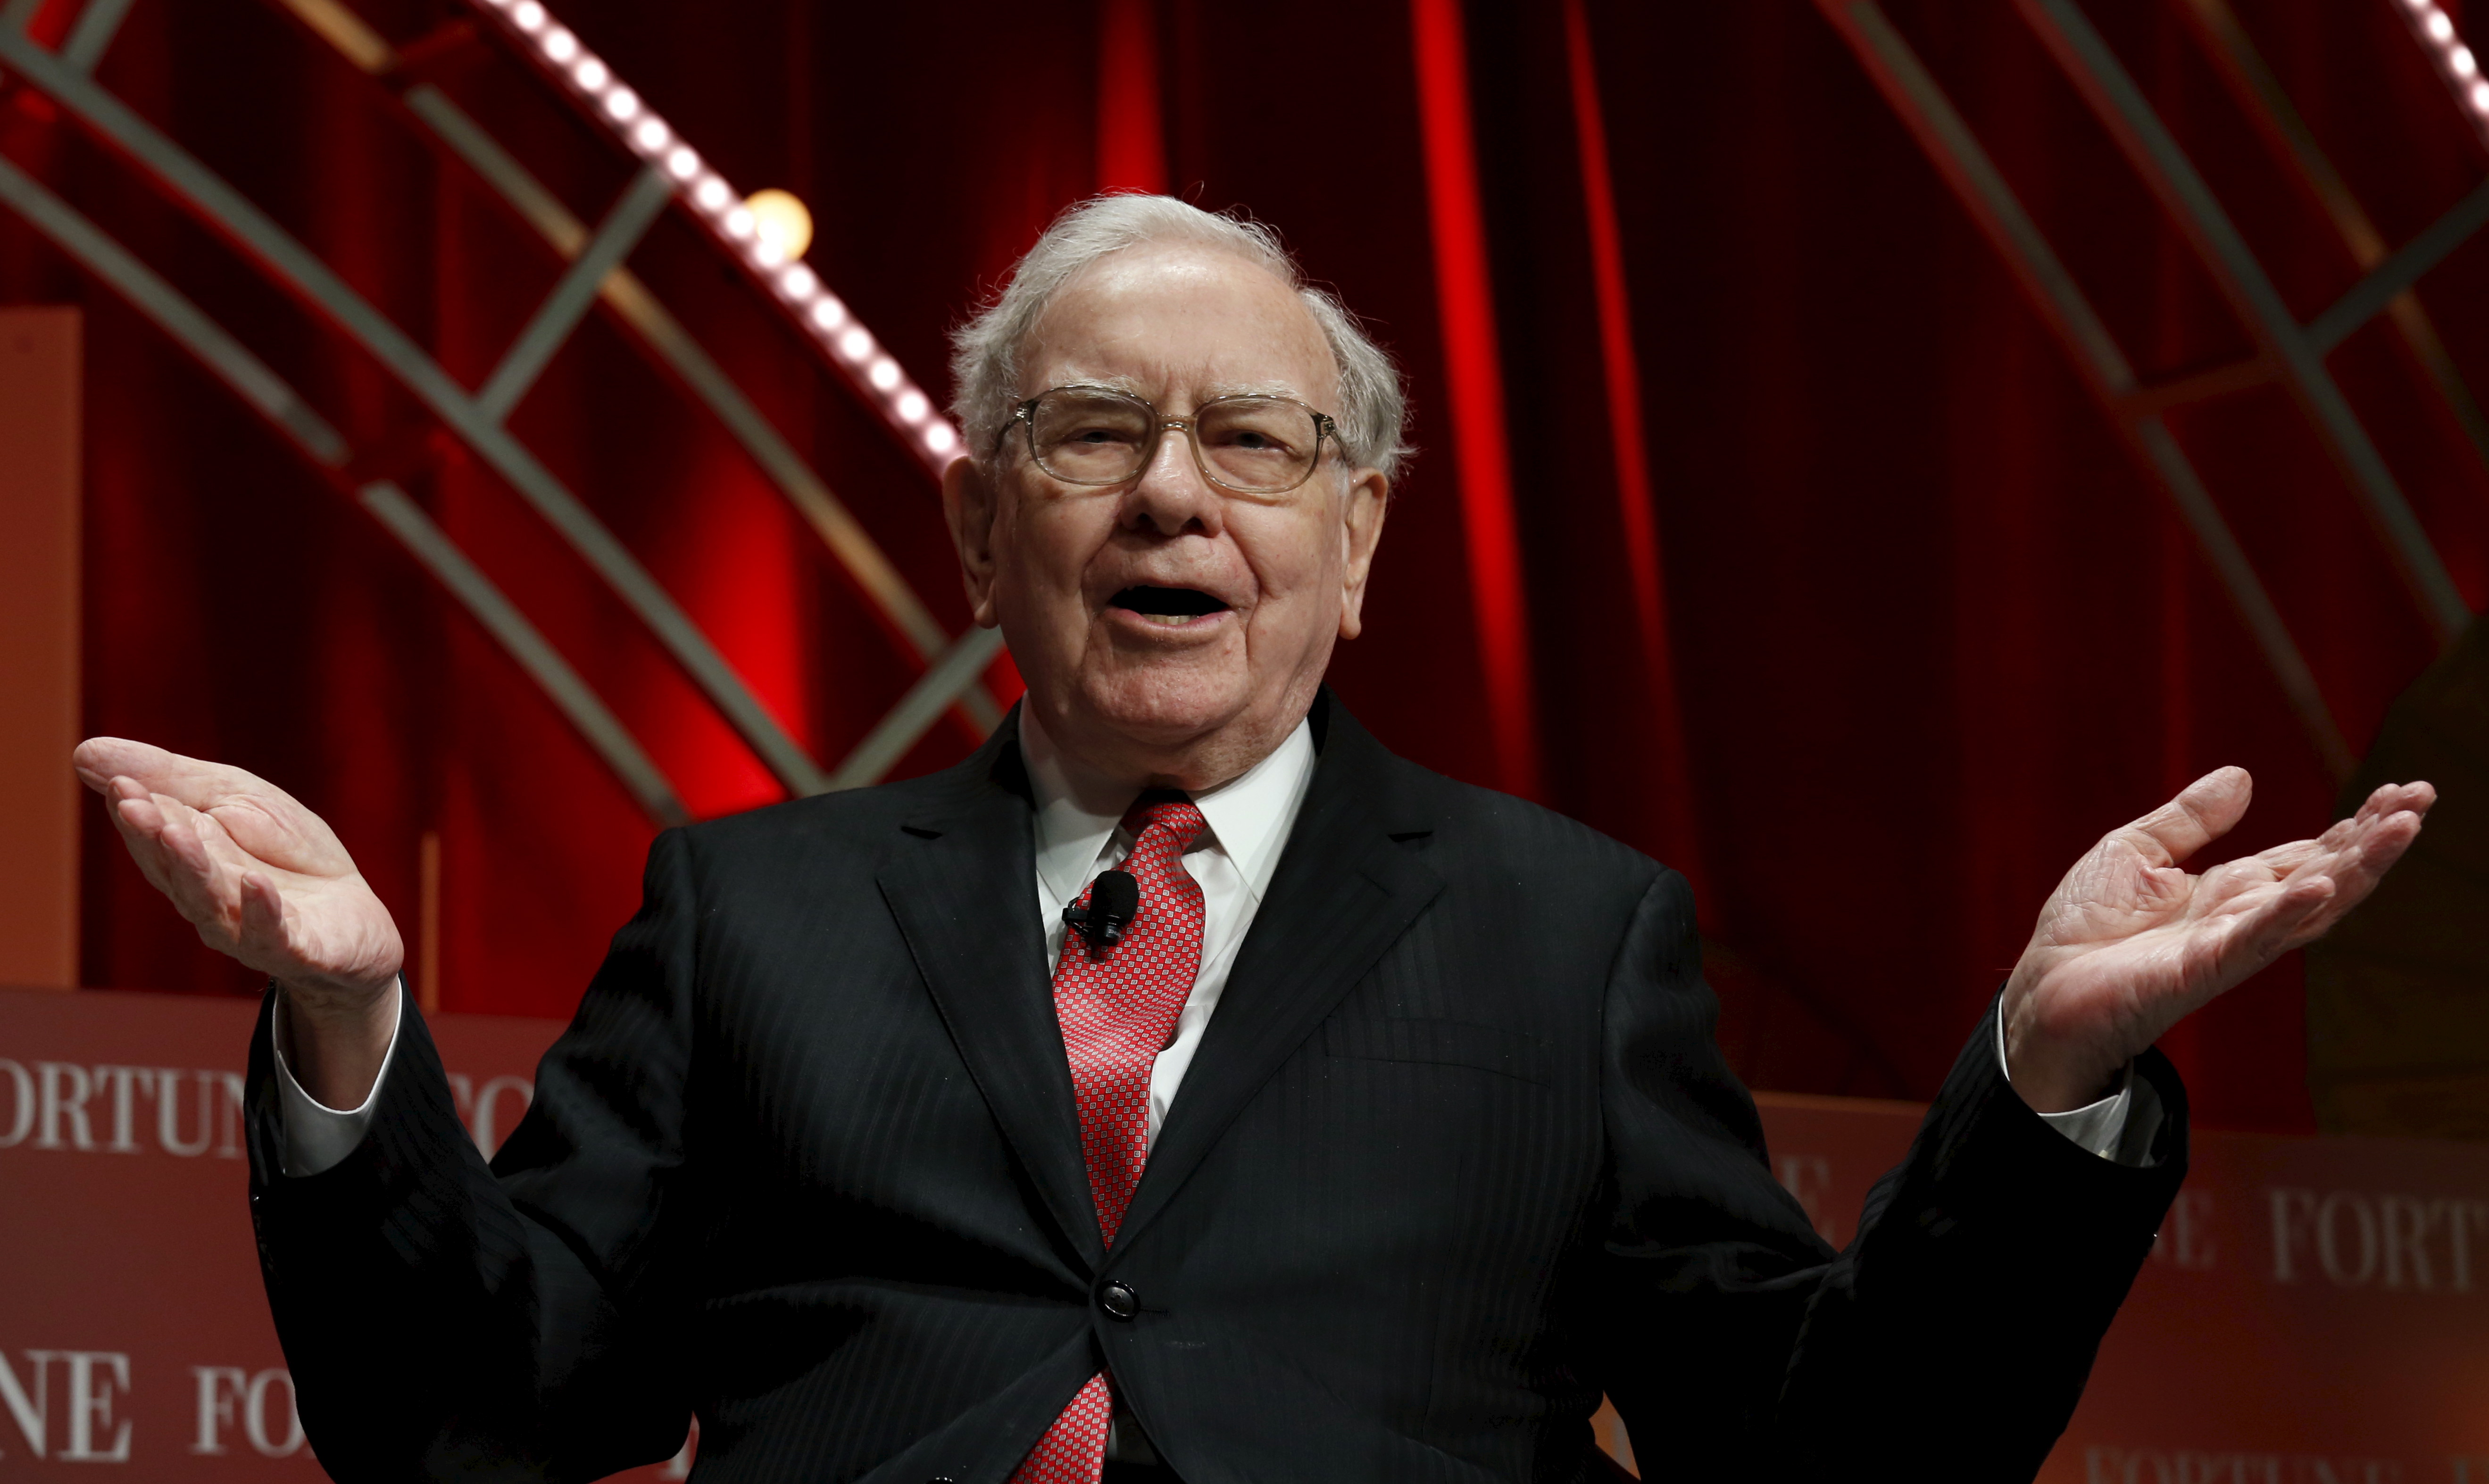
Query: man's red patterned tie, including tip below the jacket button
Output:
[[1010, 794, 1205, 1484]]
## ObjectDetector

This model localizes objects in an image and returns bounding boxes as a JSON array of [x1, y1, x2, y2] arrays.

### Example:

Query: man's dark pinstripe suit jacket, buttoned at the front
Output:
[[249, 695, 2185, 1484]]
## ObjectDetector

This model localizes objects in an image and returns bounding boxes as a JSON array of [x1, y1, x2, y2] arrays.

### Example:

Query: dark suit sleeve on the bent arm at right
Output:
[[1590, 871, 2185, 1479]]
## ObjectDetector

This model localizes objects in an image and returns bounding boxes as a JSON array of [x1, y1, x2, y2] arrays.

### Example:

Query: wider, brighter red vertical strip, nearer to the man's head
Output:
[[1409, 0, 1540, 797]]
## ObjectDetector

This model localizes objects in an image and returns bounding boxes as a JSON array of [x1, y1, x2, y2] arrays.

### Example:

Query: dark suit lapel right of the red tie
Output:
[[1120, 690, 1444, 1245]]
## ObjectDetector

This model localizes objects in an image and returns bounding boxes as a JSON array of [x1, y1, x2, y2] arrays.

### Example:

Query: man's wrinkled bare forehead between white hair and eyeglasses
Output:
[[1021, 244, 1339, 414]]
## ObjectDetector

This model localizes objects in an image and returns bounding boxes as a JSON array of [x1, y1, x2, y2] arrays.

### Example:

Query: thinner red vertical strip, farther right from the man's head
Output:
[[1563, 0, 1710, 914]]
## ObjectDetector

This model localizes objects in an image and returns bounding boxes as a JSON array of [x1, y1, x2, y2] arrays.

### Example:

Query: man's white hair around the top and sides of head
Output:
[[951, 192, 1409, 478]]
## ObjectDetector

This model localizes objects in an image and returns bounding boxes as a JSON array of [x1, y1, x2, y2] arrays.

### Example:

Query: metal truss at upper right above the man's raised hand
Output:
[[1817, 0, 2489, 779]]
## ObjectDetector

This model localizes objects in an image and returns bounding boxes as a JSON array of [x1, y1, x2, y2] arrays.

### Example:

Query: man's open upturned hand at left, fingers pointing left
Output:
[[72, 737, 406, 1108]]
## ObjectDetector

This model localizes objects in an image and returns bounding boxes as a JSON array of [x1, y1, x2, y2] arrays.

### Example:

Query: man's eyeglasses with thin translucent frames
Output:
[[996, 386, 1339, 496]]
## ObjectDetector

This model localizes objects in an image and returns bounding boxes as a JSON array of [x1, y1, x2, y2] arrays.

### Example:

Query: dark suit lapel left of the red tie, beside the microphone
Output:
[[879, 720, 1105, 1268]]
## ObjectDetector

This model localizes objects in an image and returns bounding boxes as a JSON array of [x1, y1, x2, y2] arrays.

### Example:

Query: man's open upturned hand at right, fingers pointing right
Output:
[[1998, 767, 2437, 1113]]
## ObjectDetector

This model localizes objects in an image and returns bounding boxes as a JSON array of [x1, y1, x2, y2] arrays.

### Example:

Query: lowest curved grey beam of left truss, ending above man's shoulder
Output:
[[0, 149, 690, 824]]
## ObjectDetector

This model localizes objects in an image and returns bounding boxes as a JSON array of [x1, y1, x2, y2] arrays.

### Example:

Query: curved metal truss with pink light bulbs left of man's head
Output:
[[0, 0, 1000, 824]]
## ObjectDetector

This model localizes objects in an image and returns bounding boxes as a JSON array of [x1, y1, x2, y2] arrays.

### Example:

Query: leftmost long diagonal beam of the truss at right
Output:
[[1817, 0, 2352, 779]]
